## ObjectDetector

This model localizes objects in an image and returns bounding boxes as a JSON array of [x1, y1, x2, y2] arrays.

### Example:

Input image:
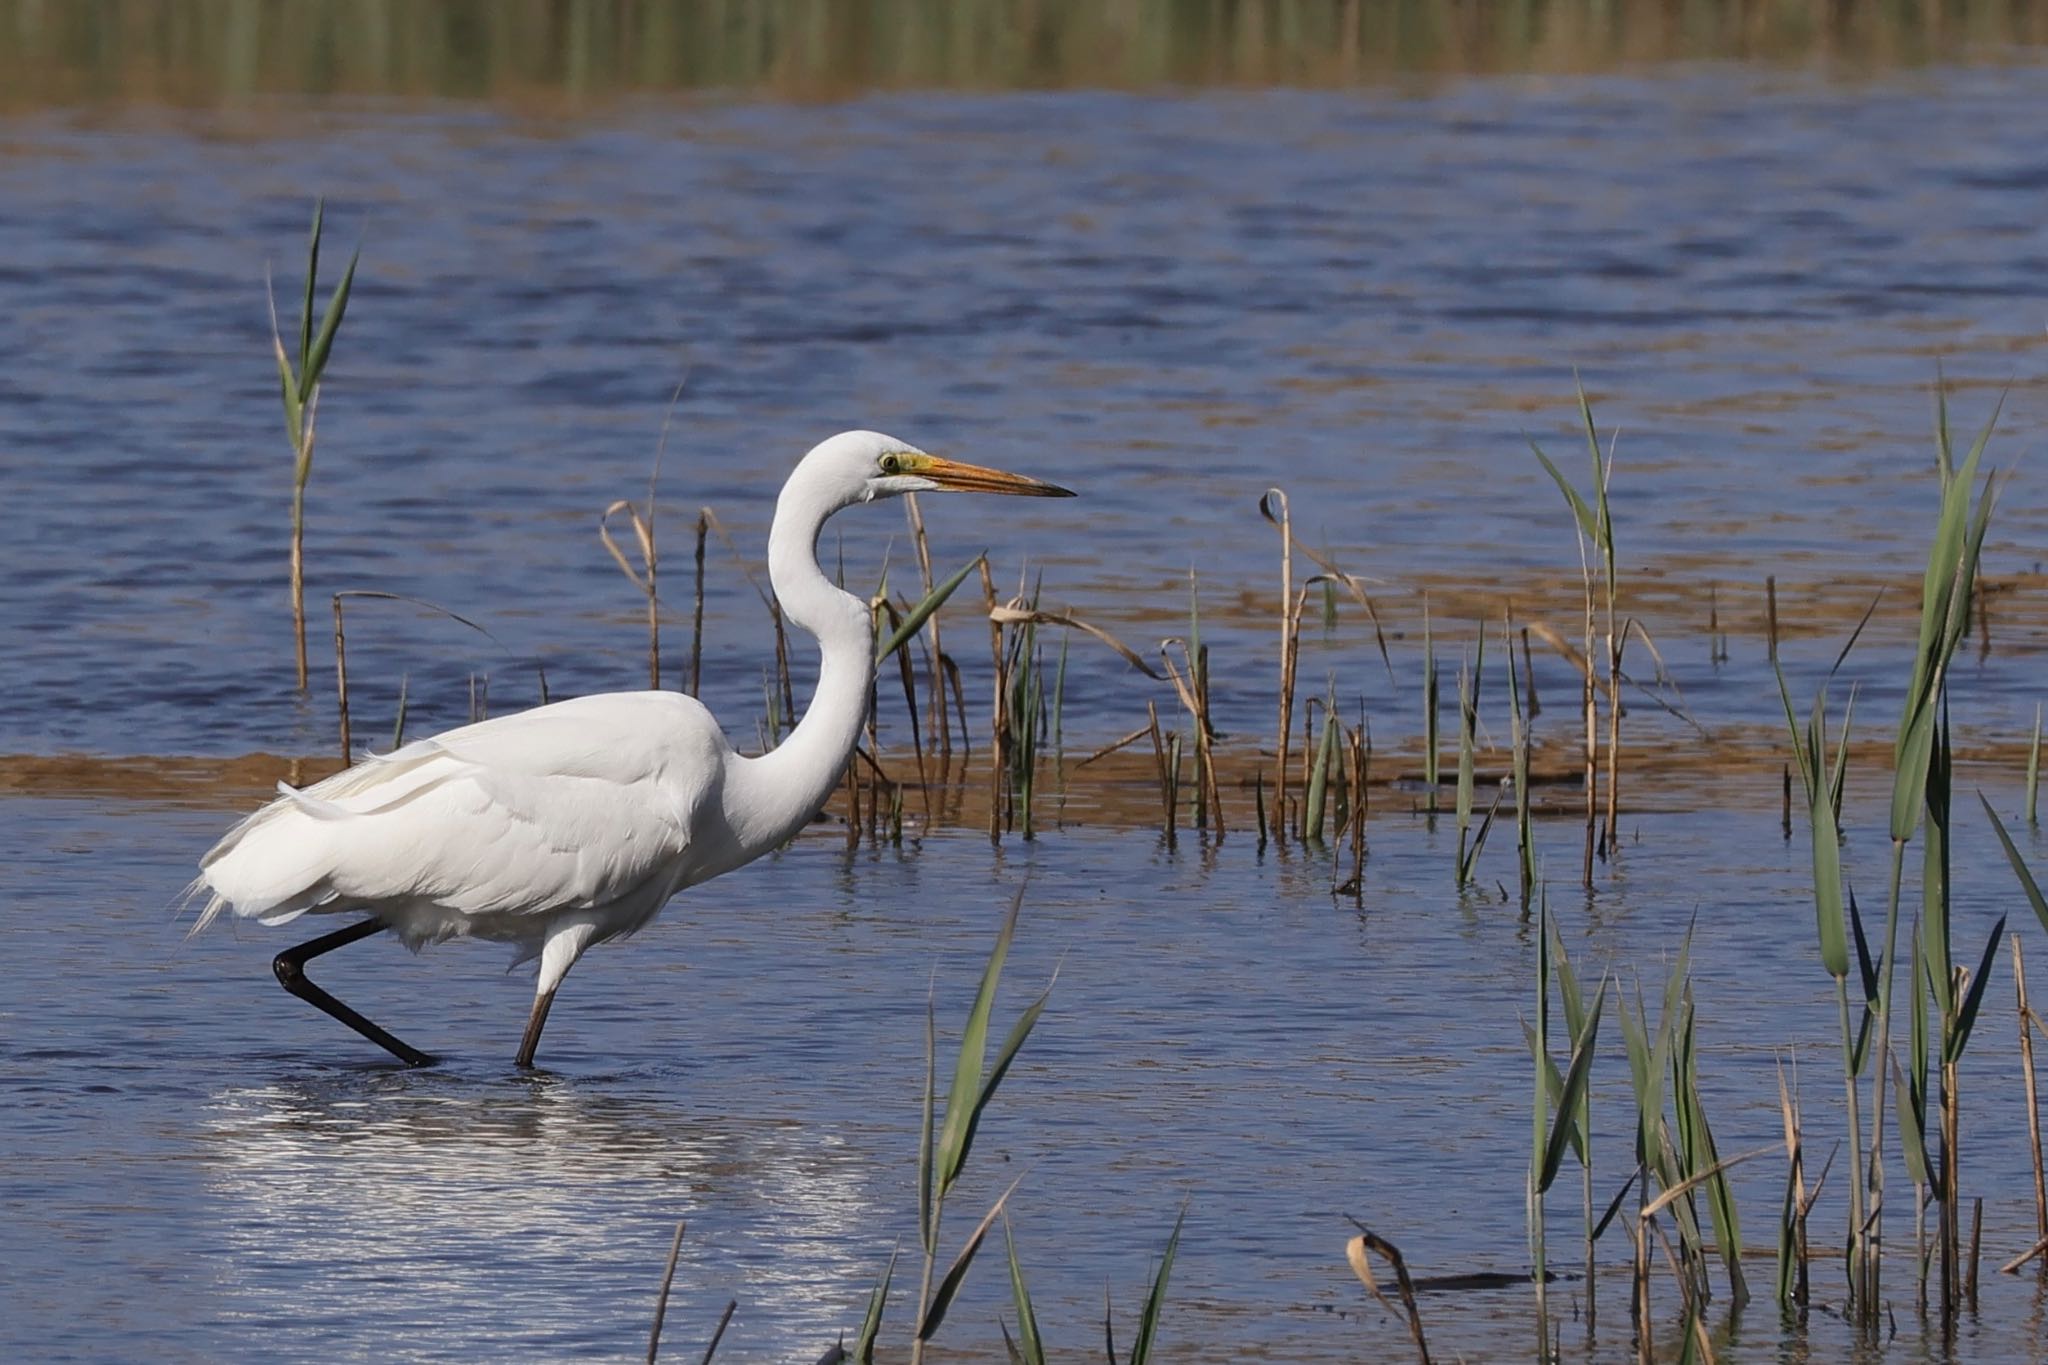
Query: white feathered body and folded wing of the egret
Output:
[[199, 692, 731, 943]]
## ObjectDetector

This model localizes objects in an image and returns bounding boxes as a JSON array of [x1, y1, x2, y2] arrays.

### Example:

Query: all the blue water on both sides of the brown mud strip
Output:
[[0, 48, 2048, 1359]]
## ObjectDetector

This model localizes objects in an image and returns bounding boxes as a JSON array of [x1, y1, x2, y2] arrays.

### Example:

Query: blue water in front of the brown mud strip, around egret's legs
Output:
[[12, 800, 2042, 1361]]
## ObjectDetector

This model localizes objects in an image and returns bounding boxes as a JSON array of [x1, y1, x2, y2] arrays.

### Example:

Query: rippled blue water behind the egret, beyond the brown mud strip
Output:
[[0, 70, 2048, 769]]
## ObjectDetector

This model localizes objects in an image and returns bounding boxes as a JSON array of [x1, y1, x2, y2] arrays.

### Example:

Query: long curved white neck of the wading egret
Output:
[[725, 479, 874, 847]]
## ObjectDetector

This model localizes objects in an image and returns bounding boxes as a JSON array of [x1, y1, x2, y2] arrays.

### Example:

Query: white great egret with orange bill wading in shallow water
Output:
[[193, 432, 1073, 1066]]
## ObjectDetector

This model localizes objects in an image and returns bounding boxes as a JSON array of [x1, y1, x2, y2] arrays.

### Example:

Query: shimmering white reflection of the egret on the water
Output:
[[203, 1070, 893, 1359]]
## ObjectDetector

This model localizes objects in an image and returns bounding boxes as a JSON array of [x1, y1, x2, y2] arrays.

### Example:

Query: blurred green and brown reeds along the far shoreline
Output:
[[0, 0, 2048, 113]]
